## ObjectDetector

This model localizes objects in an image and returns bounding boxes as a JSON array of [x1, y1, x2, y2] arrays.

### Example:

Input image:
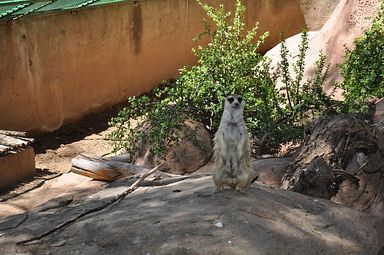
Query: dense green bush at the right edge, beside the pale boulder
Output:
[[341, 1, 384, 111]]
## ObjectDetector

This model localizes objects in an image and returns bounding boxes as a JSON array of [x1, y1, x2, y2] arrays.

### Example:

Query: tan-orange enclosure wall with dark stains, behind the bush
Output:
[[0, 0, 304, 132]]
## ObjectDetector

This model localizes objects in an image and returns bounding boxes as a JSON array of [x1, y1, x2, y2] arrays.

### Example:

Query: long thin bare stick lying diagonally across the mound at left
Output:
[[16, 163, 164, 245]]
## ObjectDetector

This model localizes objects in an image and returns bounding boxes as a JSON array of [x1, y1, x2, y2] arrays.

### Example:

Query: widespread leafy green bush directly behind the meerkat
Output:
[[110, 0, 329, 159]]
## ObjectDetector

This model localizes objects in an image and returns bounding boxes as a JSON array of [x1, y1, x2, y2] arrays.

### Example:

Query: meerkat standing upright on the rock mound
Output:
[[213, 95, 252, 193]]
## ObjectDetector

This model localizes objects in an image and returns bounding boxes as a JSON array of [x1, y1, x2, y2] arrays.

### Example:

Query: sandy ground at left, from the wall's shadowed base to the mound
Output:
[[0, 108, 117, 219]]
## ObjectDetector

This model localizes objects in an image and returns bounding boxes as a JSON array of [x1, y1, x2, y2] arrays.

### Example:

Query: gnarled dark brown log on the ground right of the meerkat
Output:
[[282, 114, 384, 214]]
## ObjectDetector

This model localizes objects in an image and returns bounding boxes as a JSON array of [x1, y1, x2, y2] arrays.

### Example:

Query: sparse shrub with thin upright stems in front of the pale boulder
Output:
[[272, 30, 334, 142]]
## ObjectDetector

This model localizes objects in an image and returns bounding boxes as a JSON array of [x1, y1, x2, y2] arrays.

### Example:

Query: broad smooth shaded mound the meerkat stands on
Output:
[[0, 177, 384, 254]]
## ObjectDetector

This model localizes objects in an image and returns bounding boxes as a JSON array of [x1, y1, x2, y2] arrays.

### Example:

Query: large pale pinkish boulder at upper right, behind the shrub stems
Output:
[[266, 0, 379, 97]]
